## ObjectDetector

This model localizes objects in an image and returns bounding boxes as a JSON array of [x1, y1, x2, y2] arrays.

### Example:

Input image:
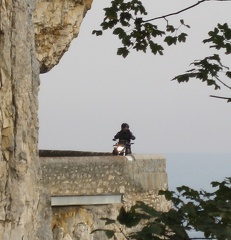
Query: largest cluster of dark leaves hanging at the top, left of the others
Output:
[[93, 0, 189, 57]]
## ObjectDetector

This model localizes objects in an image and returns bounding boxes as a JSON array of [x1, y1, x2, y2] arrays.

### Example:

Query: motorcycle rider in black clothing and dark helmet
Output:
[[113, 123, 136, 155]]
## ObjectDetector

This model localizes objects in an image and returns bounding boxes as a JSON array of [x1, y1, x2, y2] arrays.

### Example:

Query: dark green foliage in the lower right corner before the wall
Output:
[[93, 178, 231, 240]]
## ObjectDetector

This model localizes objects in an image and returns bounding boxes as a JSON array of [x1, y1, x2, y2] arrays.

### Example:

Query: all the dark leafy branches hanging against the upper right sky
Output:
[[93, 0, 231, 102]]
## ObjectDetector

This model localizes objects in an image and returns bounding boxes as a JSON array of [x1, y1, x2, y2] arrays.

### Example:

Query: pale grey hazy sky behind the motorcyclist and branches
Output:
[[39, 0, 231, 155]]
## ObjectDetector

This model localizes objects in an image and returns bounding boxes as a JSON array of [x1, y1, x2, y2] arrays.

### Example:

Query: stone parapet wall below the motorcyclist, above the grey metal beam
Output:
[[40, 155, 167, 196]]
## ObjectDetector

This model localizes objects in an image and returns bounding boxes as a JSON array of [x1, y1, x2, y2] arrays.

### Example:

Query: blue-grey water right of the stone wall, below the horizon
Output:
[[164, 153, 231, 191]]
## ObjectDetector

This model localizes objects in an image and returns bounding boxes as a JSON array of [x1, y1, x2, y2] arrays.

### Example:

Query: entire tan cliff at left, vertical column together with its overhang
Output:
[[0, 0, 91, 240]]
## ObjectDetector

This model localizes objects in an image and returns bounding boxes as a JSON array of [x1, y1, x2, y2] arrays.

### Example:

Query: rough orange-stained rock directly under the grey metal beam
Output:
[[52, 204, 121, 240]]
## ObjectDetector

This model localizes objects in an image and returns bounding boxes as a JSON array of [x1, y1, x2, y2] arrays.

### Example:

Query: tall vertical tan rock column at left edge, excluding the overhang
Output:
[[0, 0, 52, 240]]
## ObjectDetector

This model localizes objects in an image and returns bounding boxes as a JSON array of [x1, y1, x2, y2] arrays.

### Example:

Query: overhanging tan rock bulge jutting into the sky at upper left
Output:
[[34, 0, 92, 73]]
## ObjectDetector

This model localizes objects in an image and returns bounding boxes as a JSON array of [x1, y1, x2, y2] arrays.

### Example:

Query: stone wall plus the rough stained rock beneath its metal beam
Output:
[[40, 155, 171, 240]]
